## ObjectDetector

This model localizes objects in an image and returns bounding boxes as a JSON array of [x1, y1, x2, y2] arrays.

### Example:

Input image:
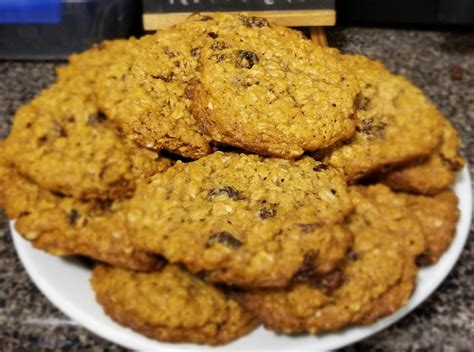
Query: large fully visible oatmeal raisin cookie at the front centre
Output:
[[125, 152, 352, 286]]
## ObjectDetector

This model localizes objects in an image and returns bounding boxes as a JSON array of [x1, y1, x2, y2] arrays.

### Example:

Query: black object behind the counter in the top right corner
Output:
[[336, 0, 474, 26]]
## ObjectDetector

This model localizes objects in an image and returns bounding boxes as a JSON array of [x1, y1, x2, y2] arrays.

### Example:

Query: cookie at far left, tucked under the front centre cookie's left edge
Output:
[[0, 158, 163, 270]]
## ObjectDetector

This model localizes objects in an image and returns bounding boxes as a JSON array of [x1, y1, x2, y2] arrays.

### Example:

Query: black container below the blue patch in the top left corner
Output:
[[0, 0, 142, 60]]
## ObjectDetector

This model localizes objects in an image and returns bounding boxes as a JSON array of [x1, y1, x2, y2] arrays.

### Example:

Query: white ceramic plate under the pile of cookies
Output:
[[10, 167, 472, 351]]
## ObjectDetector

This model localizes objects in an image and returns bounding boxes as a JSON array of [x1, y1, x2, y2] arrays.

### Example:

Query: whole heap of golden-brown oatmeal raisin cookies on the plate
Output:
[[0, 14, 464, 345]]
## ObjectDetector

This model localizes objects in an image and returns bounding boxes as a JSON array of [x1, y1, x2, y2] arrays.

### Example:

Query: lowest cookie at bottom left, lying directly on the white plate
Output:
[[91, 265, 258, 345]]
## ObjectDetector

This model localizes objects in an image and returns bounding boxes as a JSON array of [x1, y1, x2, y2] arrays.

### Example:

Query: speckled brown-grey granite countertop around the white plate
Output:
[[0, 28, 474, 351]]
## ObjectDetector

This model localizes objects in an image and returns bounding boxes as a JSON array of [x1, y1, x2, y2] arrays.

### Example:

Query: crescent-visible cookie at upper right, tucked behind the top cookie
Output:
[[315, 55, 442, 182]]
